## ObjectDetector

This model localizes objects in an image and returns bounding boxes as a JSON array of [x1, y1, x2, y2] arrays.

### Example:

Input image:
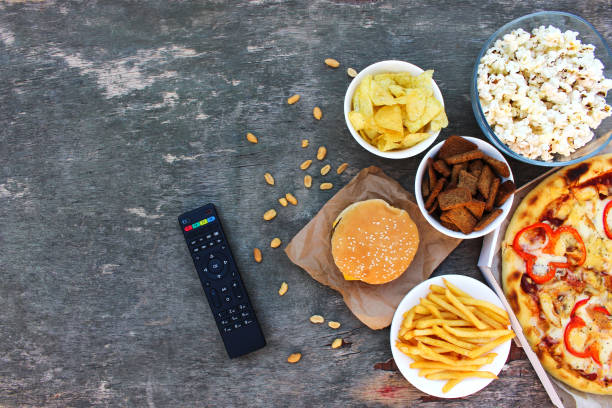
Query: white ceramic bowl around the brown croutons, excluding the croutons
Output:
[[414, 136, 514, 239]]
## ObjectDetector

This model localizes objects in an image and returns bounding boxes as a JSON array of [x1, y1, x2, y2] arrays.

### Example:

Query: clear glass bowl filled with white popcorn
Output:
[[471, 11, 612, 166]]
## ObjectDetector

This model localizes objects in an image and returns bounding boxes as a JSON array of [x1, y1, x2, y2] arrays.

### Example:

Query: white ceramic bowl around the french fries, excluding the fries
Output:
[[390, 275, 512, 398]]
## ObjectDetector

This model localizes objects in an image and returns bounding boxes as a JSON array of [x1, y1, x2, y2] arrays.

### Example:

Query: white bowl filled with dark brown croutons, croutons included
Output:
[[414, 135, 516, 239]]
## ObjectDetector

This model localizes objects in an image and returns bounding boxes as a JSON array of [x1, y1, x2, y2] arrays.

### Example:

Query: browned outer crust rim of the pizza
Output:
[[501, 154, 612, 394]]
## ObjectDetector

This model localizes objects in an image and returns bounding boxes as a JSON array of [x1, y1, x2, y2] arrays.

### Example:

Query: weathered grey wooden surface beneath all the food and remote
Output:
[[0, 0, 612, 407]]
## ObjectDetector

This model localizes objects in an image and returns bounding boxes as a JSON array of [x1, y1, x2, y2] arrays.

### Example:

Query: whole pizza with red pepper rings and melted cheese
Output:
[[501, 154, 612, 394]]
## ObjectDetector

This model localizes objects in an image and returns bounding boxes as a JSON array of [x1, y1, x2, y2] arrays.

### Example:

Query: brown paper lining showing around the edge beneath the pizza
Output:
[[482, 145, 612, 408]]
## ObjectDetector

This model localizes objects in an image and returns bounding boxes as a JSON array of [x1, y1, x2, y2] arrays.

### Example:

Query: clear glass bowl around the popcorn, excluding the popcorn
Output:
[[470, 11, 612, 167]]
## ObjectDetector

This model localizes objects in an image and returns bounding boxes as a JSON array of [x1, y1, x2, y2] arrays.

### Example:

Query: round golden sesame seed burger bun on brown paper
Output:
[[331, 199, 419, 285]]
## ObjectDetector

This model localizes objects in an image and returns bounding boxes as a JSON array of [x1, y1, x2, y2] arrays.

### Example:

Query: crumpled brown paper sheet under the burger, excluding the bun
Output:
[[285, 166, 461, 330]]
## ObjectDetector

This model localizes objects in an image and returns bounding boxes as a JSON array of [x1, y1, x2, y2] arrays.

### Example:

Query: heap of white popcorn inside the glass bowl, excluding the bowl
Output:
[[477, 26, 612, 160]]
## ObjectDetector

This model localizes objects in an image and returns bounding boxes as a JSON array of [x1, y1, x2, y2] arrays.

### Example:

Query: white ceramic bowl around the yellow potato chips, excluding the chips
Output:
[[344, 60, 444, 159]]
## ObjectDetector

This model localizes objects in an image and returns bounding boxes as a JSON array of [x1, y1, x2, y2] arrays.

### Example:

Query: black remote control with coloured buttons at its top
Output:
[[179, 204, 266, 358]]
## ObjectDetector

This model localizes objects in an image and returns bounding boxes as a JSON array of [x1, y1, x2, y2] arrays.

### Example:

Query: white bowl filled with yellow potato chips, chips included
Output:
[[344, 60, 448, 159]]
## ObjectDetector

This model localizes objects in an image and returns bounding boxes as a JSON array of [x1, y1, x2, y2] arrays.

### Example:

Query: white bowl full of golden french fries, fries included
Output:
[[390, 275, 514, 398]]
